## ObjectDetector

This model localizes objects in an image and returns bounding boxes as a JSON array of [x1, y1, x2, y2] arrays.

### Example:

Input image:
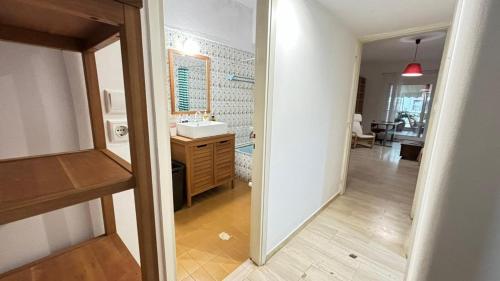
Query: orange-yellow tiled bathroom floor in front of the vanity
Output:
[[175, 181, 250, 281]]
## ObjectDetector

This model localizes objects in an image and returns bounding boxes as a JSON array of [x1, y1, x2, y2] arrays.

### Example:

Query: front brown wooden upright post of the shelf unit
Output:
[[120, 5, 159, 281]]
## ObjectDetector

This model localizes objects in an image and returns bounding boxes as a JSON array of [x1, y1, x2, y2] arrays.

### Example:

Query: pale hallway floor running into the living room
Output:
[[226, 143, 419, 281]]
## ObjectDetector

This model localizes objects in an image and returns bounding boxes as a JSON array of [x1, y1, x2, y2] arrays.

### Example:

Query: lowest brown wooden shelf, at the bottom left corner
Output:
[[0, 234, 141, 281]]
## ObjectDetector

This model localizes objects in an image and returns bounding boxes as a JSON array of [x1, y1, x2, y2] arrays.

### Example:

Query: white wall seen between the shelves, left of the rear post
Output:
[[0, 42, 103, 272]]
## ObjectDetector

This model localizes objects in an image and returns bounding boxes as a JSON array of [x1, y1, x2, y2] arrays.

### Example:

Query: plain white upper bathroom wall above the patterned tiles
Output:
[[164, 0, 255, 52]]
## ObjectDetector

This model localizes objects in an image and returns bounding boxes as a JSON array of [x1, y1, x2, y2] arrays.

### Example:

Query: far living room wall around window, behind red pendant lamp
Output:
[[360, 61, 440, 132]]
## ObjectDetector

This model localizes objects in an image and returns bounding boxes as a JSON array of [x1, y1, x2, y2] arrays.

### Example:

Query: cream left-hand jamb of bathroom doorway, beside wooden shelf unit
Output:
[[141, 1, 176, 281]]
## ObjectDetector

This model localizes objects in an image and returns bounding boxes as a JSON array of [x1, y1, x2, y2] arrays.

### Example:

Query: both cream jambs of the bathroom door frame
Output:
[[148, 0, 276, 280]]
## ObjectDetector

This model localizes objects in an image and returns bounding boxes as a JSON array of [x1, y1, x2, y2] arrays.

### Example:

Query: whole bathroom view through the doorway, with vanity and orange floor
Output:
[[165, 0, 256, 280]]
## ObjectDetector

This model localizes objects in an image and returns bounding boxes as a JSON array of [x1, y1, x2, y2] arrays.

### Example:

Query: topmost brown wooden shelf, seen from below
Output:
[[0, 0, 124, 51]]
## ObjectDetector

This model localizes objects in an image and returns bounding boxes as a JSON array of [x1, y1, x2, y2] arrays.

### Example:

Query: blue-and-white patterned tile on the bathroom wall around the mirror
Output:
[[165, 28, 255, 180]]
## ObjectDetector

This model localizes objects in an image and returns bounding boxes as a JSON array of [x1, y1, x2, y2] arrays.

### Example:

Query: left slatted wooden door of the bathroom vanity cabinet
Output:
[[191, 143, 214, 191]]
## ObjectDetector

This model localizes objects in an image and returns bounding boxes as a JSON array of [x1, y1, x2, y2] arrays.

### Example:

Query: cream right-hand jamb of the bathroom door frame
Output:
[[250, 0, 277, 265]]
